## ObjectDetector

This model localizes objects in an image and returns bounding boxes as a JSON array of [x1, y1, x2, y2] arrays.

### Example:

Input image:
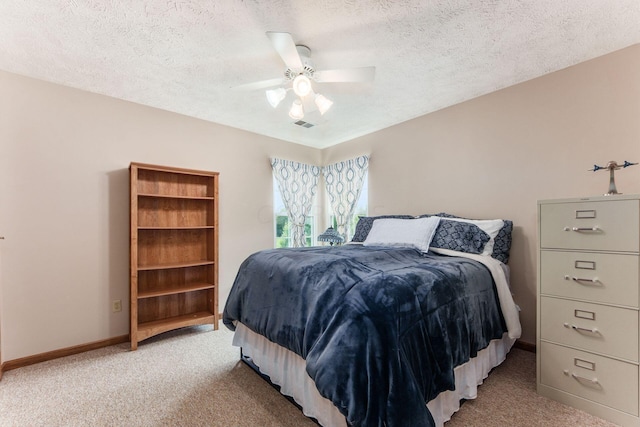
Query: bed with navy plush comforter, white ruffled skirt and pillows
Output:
[[223, 214, 520, 427]]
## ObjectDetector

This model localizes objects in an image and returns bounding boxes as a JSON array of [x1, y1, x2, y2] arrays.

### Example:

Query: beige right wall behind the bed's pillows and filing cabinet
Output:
[[322, 45, 640, 343]]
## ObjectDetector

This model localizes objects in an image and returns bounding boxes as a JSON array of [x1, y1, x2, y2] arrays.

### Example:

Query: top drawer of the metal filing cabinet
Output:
[[540, 200, 640, 252]]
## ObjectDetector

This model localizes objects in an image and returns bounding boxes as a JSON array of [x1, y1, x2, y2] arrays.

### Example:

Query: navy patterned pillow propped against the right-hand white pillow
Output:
[[431, 218, 491, 254]]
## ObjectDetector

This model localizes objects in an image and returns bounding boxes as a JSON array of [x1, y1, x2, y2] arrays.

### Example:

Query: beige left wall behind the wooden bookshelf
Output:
[[0, 72, 320, 361]]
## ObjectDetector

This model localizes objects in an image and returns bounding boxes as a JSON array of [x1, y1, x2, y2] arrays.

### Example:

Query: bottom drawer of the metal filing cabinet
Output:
[[540, 342, 638, 416]]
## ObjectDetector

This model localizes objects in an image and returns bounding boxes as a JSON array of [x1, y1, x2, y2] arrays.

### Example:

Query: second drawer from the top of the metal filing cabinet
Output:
[[540, 251, 640, 307]]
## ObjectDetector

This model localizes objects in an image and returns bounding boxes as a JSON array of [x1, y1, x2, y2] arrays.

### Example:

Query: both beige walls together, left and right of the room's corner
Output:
[[0, 45, 640, 361]]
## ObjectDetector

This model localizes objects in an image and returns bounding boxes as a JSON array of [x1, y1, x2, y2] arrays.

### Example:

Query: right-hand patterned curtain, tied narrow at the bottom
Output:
[[323, 156, 369, 241]]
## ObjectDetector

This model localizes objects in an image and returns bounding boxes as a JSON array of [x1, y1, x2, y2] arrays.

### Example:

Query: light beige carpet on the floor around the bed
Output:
[[0, 327, 613, 427]]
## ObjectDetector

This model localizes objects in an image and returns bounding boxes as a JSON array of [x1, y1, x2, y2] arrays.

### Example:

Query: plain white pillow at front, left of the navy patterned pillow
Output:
[[363, 216, 440, 252]]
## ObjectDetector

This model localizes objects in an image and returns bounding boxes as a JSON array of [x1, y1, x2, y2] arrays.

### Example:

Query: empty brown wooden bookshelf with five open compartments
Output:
[[130, 163, 218, 350]]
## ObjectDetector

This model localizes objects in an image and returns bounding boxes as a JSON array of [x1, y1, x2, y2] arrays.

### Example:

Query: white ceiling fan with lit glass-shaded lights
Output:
[[235, 31, 376, 120]]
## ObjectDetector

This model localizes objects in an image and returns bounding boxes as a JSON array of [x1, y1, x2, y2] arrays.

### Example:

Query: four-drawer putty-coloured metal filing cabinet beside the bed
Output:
[[537, 195, 640, 426]]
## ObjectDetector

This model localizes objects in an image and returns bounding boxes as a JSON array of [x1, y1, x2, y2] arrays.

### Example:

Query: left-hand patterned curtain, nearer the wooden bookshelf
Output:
[[271, 159, 320, 248]]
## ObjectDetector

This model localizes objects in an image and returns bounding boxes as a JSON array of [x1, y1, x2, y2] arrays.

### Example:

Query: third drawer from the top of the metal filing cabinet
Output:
[[540, 297, 638, 362]]
